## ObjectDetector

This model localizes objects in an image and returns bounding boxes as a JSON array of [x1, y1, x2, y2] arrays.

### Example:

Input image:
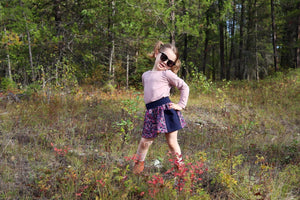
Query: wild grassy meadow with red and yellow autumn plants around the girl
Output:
[[0, 70, 300, 199]]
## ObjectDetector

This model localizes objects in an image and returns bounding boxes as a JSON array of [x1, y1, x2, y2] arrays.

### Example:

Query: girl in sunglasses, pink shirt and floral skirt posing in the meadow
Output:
[[133, 42, 189, 174]]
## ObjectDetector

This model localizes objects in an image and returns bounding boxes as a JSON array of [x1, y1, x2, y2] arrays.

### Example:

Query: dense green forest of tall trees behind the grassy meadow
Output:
[[0, 0, 300, 87]]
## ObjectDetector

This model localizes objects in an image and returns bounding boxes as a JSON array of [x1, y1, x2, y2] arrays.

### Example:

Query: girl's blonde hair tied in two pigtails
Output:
[[149, 41, 181, 74]]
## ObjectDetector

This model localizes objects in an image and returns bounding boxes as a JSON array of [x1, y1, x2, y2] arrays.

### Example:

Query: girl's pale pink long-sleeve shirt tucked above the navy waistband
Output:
[[142, 70, 189, 108]]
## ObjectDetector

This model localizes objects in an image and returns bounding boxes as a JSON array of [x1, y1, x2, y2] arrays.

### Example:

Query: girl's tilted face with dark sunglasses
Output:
[[153, 48, 176, 71]]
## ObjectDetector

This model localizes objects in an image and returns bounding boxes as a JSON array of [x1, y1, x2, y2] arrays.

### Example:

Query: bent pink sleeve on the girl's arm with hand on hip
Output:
[[166, 70, 190, 108]]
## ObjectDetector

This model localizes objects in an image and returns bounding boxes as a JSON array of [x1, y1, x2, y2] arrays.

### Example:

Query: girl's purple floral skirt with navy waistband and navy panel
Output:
[[142, 97, 186, 138]]
